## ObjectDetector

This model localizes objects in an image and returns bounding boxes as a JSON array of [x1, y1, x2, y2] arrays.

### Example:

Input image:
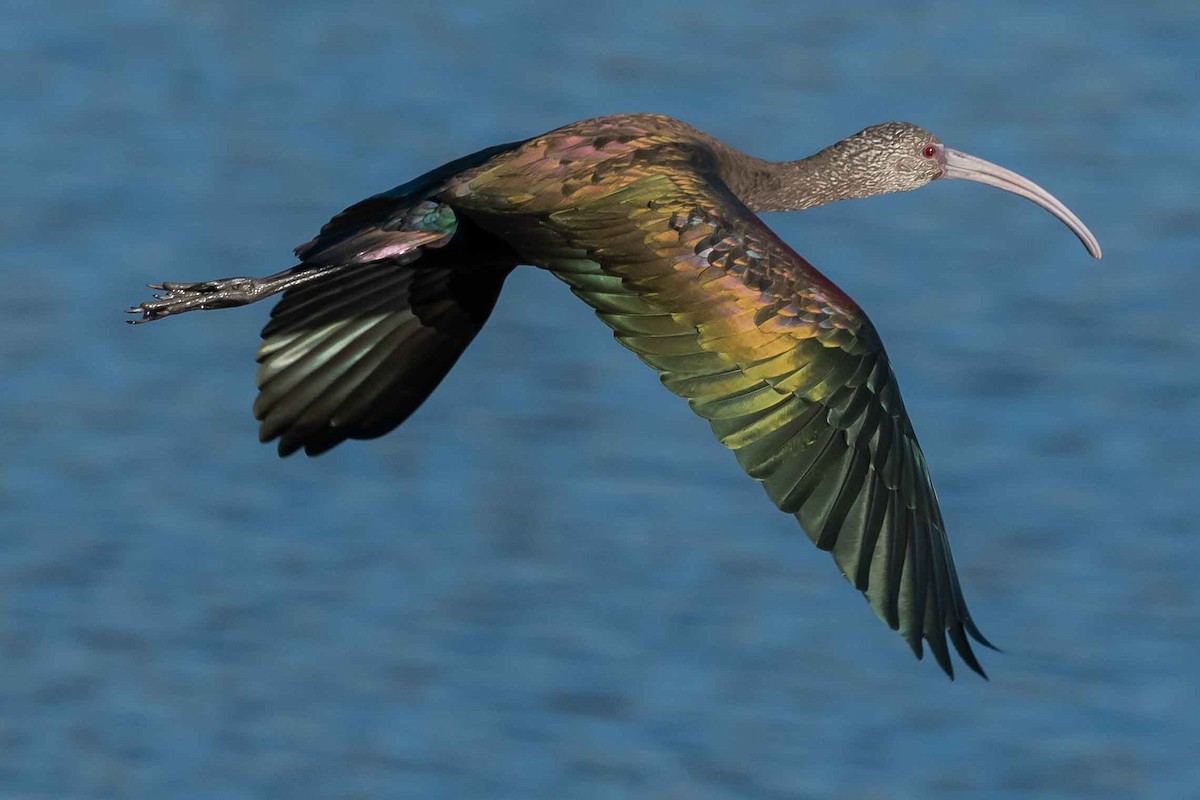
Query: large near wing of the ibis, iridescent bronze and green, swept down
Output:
[[448, 142, 991, 678]]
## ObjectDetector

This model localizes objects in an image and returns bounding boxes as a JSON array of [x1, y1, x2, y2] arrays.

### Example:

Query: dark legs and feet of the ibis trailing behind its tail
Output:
[[126, 265, 340, 325]]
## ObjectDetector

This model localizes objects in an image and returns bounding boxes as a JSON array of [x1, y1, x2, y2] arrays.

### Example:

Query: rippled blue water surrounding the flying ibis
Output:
[[0, 0, 1200, 798]]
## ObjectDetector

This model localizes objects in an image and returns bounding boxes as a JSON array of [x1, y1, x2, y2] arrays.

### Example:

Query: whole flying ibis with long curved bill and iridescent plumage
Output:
[[130, 114, 1100, 678]]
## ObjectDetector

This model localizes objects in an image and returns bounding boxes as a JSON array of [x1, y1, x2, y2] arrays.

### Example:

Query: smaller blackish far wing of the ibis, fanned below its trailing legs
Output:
[[254, 256, 515, 456]]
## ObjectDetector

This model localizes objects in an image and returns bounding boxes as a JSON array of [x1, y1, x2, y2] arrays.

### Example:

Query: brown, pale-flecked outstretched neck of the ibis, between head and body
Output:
[[722, 143, 886, 212]]
